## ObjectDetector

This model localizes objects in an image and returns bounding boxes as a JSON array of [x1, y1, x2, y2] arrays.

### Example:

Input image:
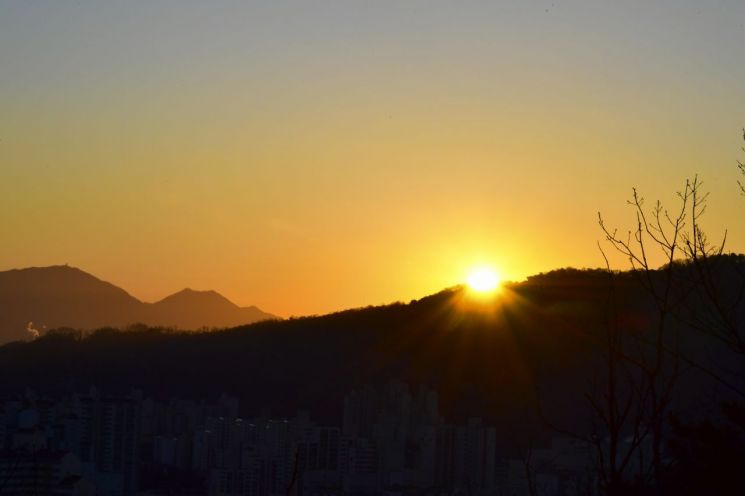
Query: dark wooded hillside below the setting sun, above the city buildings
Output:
[[0, 262, 739, 446]]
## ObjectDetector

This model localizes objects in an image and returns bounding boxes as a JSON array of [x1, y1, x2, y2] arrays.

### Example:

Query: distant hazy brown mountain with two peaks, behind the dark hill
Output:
[[0, 265, 277, 343]]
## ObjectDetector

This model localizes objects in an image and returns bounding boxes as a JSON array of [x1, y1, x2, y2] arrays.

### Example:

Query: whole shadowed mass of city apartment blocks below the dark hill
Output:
[[0, 382, 594, 496]]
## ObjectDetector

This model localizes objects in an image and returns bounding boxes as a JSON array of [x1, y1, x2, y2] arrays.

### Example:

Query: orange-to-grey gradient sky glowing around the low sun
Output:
[[0, 0, 745, 316]]
